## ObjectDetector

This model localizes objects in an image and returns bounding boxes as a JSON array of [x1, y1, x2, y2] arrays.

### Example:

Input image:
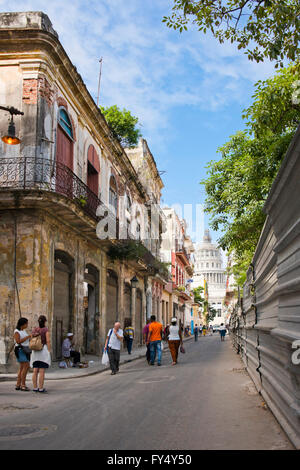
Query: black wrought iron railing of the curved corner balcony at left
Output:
[[0, 157, 103, 219]]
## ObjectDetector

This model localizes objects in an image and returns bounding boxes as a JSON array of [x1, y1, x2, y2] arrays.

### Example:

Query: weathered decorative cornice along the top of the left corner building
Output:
[[0, 24, 148, 200]]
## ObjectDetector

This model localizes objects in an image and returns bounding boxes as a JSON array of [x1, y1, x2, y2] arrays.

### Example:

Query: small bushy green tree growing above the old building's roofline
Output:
[[100, 105, 142, 148]]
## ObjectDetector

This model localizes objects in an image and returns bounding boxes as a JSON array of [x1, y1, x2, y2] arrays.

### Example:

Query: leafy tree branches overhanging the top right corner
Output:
[[162, 0, 300, 67]]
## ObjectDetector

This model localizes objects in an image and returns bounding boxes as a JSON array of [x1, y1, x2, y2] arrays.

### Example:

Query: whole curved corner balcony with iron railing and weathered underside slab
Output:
[[0, 157, 124, 245]]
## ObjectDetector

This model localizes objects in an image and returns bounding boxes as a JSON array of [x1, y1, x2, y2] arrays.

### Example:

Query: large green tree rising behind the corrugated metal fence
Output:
[[202, 67, 300, 285]]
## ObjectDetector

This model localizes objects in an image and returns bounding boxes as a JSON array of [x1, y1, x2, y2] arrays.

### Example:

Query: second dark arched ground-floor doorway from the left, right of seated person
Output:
[[83, 264, 99, 354]]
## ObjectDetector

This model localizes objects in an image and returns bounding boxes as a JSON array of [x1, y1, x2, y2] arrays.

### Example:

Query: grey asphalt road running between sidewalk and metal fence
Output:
[[0, 333, 293, 450]]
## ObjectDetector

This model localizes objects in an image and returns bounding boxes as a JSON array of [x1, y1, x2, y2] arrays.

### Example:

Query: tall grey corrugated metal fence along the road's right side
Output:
[[231, 128, 300, 449]]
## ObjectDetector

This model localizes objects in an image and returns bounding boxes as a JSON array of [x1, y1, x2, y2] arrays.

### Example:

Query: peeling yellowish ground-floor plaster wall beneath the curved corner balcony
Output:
[[0, 210, 105, 364]]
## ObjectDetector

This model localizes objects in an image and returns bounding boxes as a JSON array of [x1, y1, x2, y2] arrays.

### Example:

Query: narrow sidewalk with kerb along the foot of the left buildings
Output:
[[0, 336, 193, 382]]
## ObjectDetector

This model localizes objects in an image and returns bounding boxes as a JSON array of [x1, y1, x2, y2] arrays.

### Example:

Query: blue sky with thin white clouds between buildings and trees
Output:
[[0, 0, 274, 246]]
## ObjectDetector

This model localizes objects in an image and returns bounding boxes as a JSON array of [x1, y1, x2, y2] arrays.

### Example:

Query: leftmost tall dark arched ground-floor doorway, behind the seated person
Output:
[[52, 250, 74, 360]]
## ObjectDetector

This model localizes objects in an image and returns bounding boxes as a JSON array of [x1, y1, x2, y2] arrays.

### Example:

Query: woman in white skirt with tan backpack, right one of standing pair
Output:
[[30, 315, 51, 393]]
